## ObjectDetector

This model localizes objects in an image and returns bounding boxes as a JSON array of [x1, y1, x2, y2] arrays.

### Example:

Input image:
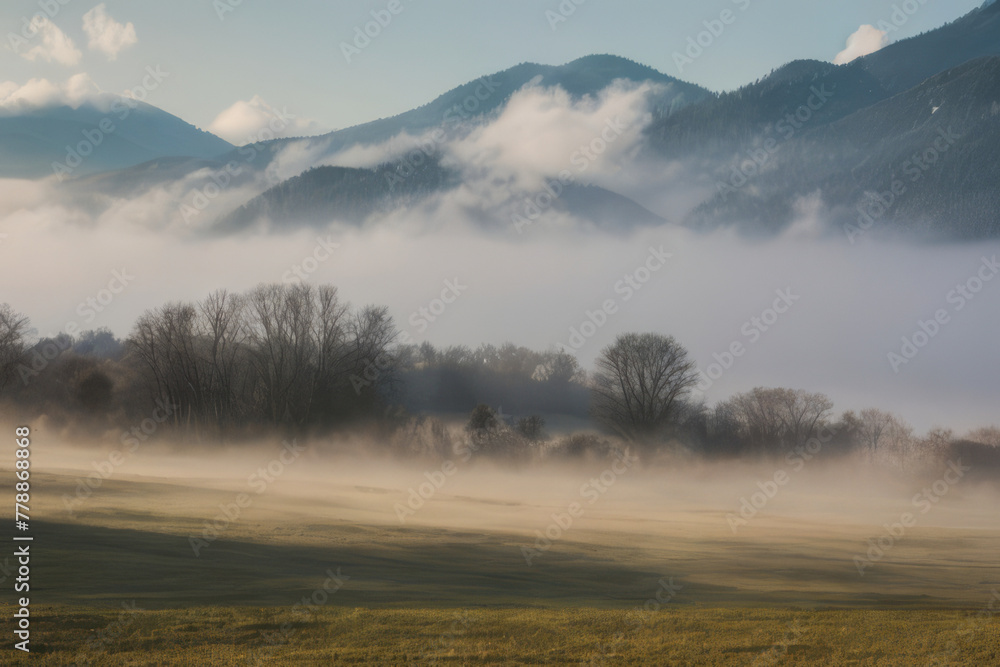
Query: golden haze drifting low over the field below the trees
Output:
[[13, 425, 1000, 607]]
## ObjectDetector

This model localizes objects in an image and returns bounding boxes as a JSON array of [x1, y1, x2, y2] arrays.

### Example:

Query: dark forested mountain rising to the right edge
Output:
[[647, 3, 1000, 239]]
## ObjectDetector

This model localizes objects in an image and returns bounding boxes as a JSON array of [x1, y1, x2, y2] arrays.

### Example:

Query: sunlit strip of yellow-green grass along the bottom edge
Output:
[[5, 605, 1000, 666]]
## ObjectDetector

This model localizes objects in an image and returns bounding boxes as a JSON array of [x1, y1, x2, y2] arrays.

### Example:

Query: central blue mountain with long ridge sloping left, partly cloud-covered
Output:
[[60, 55, 712, 224]]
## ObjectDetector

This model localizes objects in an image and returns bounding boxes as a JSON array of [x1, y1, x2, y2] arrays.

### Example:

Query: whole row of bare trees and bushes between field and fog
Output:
[[0, 284, 1000, 466]]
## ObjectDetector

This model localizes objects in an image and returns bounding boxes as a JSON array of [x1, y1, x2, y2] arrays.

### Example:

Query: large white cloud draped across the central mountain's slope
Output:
[[266, 81, 664, 214]]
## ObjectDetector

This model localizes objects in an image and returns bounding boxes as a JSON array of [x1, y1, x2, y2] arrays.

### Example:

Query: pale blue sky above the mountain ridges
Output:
[[0, 0, 981, 133]]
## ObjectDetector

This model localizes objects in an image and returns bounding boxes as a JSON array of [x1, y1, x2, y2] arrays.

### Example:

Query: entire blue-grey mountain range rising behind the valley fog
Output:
[[15, 2, 1000, 239]]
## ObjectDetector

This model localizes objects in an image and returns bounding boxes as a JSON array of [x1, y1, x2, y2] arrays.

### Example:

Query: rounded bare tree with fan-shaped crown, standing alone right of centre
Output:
[[593, 333, 697, 440]]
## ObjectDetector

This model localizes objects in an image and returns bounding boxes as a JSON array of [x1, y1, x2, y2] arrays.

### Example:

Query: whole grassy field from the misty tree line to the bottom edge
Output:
[[0, 440, 1000, 666]]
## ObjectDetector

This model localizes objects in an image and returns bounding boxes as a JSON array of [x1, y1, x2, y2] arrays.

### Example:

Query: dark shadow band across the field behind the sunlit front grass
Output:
[[32, 521, 704, 609]]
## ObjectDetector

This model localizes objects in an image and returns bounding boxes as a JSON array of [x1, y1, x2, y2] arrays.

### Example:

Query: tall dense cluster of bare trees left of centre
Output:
[[128, 285, 396, 432]]
